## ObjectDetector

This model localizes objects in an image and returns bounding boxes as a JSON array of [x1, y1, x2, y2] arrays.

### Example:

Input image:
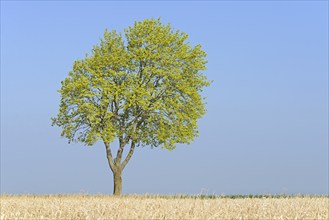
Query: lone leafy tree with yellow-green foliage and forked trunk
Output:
[[52, 19, 210, 195]]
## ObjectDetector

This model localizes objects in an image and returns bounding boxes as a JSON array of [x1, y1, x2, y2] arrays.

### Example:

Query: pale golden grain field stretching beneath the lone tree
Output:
[[0, 195, 329, 220]]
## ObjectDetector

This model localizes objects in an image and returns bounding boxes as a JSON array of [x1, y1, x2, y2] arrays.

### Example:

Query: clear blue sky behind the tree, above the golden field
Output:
[[1, 1, 328, 194]]
